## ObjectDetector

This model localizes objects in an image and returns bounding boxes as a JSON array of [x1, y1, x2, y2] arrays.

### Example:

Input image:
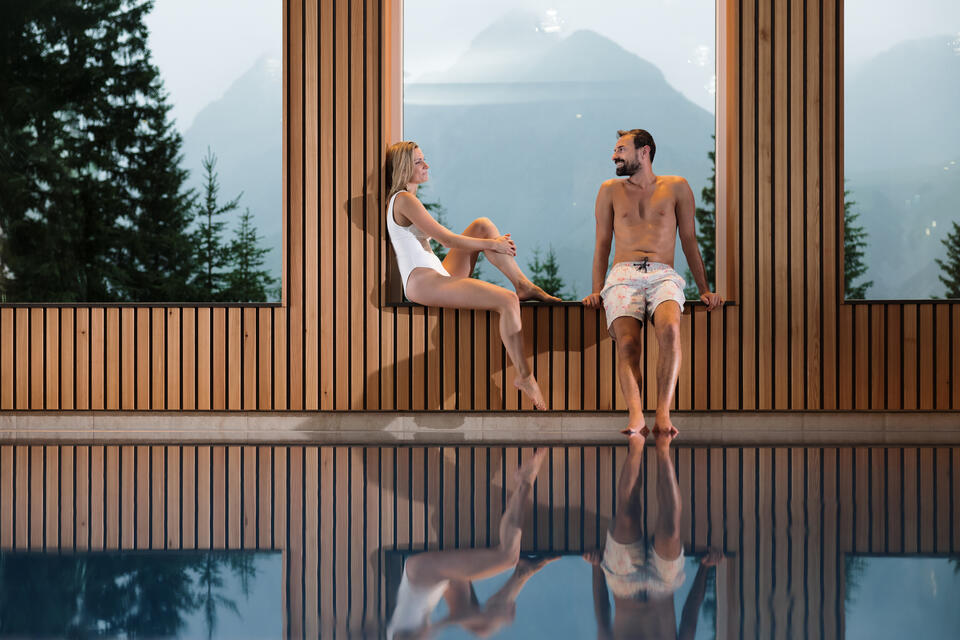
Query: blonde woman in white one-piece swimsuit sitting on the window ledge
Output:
[[386, 142, 559, 410]]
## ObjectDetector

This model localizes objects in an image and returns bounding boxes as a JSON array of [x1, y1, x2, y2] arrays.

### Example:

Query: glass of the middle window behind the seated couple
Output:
[[403, 0, 716, 299]]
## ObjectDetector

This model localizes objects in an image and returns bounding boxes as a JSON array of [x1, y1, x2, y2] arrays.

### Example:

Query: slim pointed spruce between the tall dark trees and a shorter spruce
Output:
[[194, 147, 237, 302]]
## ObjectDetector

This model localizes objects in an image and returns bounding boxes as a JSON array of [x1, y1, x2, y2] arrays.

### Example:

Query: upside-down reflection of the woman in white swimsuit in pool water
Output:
[[387, 449, 552, 640]]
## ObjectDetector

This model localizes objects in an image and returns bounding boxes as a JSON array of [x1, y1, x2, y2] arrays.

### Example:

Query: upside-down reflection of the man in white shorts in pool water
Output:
[[584, 428, 721, 640]]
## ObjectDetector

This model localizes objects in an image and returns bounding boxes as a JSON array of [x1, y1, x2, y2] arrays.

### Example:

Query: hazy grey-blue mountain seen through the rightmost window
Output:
[[844, 35, 960, 299]]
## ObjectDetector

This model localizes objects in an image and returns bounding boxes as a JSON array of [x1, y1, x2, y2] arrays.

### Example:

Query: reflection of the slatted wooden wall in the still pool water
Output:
[[0, 445, 960, 638]]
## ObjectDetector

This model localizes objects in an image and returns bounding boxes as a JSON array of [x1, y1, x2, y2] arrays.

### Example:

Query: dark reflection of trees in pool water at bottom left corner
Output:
[[0, 553, 256, 638]]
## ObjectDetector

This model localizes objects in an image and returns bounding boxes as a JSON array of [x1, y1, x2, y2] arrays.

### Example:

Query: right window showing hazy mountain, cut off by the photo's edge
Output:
[[844, 0, 960, 300]]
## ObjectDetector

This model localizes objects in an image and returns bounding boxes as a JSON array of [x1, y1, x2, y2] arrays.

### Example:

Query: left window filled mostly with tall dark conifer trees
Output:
[[0, 0, 283, 302]]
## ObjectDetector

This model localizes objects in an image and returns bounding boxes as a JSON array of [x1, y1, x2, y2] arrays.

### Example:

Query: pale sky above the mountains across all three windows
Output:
[[146, 0, 960, 132]]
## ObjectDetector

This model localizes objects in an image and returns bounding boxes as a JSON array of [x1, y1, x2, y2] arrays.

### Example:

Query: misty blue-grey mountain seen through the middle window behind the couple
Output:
[[403, 12, 714, 296]]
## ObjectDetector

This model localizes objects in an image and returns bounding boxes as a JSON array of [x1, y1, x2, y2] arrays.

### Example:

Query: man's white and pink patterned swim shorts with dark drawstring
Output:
[[600, 260, 687, 330]]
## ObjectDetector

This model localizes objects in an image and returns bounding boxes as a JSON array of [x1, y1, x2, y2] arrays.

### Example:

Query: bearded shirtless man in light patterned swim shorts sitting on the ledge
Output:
[[583, 129, 723, 435]]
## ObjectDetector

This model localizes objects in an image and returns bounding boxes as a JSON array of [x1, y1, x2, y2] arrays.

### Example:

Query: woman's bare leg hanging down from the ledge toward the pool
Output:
[[407, 268, 547, 410]]
